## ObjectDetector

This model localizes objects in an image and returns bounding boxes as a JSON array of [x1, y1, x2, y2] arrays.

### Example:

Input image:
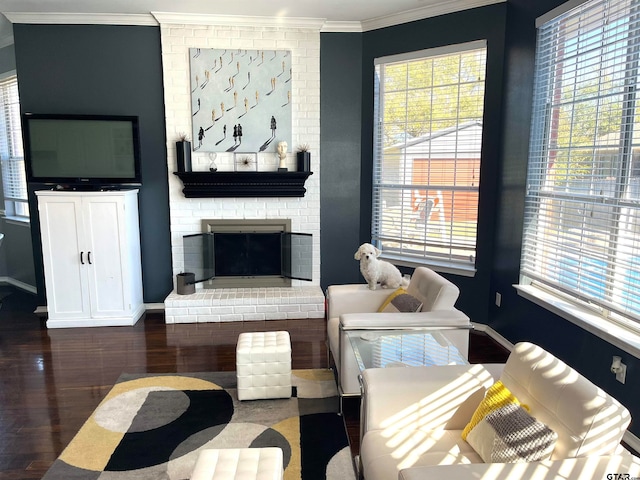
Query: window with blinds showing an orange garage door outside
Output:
[[372, 41, 486, 272]]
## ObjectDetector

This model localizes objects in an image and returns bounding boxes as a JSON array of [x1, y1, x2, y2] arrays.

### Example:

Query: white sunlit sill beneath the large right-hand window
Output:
[[514, 285, 640, 358]]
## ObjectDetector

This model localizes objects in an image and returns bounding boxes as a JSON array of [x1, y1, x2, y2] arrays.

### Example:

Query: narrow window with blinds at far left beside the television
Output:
[[0, 75, 29, 221]]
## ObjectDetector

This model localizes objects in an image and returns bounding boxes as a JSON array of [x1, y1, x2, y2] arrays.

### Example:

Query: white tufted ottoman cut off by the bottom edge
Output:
[[191, 447, 284, 480]]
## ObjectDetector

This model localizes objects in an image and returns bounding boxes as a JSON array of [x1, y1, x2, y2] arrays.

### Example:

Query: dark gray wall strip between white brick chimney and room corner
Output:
[[320, 33, 363, 289]]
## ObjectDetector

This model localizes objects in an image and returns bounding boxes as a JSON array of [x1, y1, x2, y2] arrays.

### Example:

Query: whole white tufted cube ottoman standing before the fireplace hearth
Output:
[[236, 332, 291, 400]]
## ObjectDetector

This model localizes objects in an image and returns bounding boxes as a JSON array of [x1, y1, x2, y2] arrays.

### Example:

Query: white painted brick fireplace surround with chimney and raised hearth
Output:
[[158, 16, 324, 323]]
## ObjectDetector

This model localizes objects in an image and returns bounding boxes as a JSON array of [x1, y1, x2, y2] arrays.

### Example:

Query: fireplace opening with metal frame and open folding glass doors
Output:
[[183, 219, 313, 288]]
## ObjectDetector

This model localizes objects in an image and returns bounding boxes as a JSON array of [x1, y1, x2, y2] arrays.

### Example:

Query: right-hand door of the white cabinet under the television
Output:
[[83, 196, 131, 318]]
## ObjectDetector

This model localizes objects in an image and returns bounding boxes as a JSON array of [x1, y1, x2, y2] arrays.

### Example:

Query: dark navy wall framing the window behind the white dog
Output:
[[358, 4, 507, 323]]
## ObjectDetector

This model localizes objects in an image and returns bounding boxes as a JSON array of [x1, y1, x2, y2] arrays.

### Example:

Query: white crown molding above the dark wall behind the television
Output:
[[2, 12, 158, 26]]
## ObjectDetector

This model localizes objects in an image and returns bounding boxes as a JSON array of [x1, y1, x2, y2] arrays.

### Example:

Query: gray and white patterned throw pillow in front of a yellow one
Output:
[[467, 403, 558, 463]]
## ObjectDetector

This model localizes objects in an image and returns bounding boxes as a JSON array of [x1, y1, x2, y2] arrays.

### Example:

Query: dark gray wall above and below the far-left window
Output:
[[0, 44, 36, 290]]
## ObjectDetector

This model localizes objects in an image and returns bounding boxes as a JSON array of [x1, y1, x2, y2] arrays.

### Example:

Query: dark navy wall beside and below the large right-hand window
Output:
[[484, 0, 640, 436]]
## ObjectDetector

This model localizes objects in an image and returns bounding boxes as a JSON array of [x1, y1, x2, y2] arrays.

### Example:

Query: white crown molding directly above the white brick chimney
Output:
[[151, 12, 325, 30]]
